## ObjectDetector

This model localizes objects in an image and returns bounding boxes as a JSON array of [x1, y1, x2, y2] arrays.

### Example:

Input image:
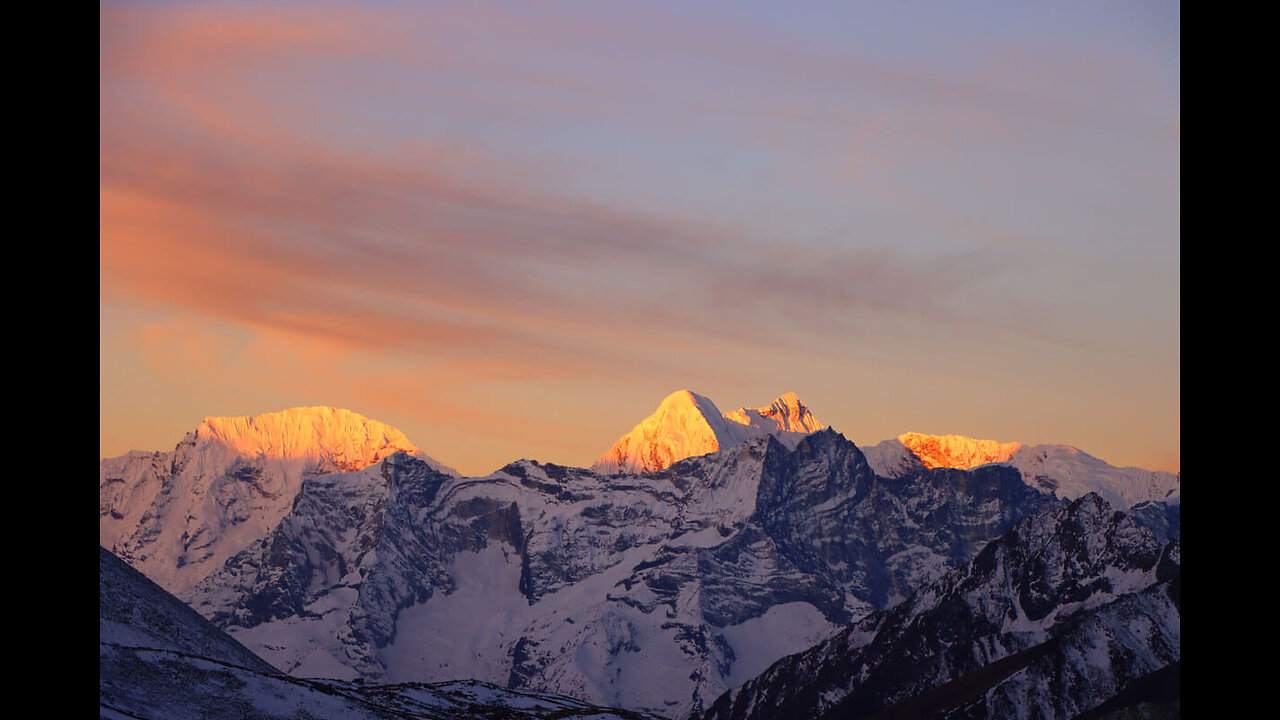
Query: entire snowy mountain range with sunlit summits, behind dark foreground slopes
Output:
[[100, 391, 1180, 717]]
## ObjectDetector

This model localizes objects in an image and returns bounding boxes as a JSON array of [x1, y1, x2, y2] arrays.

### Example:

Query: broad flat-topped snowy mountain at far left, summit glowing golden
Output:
[[99, 407, 456, 593]]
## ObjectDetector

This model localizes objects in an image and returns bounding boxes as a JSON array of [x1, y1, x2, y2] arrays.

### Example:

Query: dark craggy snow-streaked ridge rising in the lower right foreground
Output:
[[698, 493, 1181, 720]]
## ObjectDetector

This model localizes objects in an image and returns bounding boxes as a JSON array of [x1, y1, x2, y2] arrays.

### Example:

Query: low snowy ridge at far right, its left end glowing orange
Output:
[[865, 433, 1181, 507]]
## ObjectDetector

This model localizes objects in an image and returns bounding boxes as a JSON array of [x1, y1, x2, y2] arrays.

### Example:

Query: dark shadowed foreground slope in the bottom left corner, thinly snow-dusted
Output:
[[99, 548, 655, 720]]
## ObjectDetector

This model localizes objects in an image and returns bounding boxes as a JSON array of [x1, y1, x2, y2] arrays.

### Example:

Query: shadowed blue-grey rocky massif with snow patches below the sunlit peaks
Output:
[[186, 430, 1056, 716]]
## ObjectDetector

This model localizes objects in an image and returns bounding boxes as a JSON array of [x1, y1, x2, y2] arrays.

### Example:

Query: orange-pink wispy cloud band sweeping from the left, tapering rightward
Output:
[[100, 2, 1018, 370]]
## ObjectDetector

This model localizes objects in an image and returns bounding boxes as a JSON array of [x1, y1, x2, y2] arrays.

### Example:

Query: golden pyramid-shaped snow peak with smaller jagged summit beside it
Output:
[[591, 389, 824, 473]]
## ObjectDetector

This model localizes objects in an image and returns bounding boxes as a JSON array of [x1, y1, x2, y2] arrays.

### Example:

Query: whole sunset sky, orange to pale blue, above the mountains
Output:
[[99, 1, 1180, 475]]
